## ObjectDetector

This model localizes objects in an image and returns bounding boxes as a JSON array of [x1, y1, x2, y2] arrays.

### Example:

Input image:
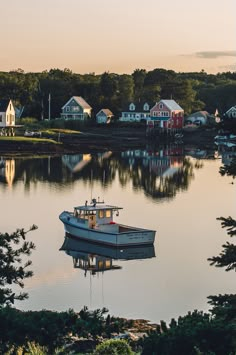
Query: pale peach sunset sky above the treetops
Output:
[[0, 0, 236, 74]]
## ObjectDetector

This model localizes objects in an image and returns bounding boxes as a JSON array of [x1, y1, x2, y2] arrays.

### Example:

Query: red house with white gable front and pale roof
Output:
[[150, 100, 184, 129]]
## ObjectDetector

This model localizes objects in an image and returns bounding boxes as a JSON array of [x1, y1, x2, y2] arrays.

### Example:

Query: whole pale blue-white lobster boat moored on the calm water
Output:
[[59, 199, 156, 246]]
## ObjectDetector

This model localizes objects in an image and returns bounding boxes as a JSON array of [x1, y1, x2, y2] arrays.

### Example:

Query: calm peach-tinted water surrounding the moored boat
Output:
[[0, 146, 235, 322]]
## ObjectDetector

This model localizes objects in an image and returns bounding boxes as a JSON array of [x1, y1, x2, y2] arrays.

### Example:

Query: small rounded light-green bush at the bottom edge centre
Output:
[[94, 339, 134, 355]]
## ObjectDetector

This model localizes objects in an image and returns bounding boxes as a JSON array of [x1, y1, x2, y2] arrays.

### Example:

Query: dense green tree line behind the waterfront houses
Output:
[[0, 68, 236, 120]]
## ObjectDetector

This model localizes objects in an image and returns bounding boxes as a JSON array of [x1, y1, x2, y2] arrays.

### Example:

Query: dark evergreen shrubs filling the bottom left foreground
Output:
[[0, 307, 133, 354]]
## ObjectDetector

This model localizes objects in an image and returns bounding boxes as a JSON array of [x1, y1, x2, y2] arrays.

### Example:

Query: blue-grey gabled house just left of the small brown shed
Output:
[[61, 96, 92, 121]]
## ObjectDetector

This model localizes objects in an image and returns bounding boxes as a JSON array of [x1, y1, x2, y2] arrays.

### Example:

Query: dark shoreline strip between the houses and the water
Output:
[[0, 128, 217, 156]]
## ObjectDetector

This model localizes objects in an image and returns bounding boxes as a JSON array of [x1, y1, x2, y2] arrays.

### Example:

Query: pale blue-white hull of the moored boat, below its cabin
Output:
[[59, 212, 156, 246]]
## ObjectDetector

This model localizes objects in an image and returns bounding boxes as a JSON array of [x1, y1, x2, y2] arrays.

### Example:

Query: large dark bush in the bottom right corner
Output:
[[140, 311, 235, 355]]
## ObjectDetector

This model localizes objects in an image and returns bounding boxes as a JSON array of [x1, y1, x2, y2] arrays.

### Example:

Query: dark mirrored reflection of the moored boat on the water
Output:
[[60, 234, 156, 276]]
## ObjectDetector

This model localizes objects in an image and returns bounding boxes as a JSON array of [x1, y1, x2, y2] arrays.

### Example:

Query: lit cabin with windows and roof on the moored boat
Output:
[[74, 199, 122, 228]]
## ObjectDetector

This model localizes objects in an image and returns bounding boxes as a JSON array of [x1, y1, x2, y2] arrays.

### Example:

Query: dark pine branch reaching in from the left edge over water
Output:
[[0, 225, 37, 308]]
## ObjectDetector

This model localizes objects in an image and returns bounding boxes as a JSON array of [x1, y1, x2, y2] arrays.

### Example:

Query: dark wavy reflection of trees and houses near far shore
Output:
[[4, 151, 201, 199]]
